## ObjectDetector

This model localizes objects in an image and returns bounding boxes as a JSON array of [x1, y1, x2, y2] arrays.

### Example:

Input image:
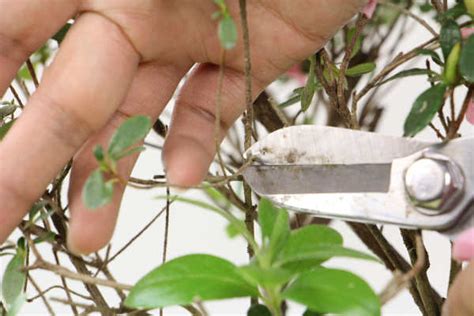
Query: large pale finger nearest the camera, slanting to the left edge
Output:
[[0, 13, 139, 243]]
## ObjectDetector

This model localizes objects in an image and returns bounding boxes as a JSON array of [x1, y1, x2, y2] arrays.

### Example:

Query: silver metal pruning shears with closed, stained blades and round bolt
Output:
[[243, 125, 474, 238]]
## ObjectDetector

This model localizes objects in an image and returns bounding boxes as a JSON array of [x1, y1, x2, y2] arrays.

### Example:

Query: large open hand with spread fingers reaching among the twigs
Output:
[[0, 0, 467, 315]]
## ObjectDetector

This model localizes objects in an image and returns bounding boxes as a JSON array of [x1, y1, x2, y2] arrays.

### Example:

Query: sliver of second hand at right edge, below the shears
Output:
[[443, 228, 474, 316]]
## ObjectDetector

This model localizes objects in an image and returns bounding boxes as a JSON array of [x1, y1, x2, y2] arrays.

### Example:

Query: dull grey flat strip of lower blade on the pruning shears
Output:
[[243, 164, 391, 195]]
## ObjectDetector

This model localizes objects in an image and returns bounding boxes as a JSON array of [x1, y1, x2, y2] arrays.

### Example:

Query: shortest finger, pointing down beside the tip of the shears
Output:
[[163, 64, 261, 187]]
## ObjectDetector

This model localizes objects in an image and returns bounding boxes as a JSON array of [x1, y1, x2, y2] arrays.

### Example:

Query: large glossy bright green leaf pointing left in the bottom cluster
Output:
[[125, 255, 258, 309]]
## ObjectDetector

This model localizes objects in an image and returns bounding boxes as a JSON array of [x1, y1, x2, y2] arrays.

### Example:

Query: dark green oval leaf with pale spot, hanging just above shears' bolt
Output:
[[404, 83, 446, 136]]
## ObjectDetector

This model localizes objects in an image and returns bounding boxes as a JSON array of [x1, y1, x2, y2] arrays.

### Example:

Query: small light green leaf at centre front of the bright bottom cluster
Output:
[[239, 264, 295, 287]]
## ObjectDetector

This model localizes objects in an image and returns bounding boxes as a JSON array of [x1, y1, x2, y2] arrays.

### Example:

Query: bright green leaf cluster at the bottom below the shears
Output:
[[125, 198, 380, 315]]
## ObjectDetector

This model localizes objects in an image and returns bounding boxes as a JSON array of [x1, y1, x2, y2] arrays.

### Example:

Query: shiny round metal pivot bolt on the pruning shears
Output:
[[405, 152, 464, 214]]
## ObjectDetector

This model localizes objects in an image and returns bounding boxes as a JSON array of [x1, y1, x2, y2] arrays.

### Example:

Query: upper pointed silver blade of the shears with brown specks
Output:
[[246, 125, 432, 165]]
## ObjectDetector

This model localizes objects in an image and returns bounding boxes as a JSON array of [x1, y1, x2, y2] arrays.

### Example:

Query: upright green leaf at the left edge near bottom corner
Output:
[[2, 250, 26, 310]]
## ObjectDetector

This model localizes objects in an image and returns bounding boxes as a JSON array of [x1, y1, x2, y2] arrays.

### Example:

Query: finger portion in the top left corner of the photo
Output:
[[0, 0, 78, 97]]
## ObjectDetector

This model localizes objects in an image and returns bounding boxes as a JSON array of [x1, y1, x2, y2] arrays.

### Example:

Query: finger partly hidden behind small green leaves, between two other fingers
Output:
[[68, 63, 187, 254]]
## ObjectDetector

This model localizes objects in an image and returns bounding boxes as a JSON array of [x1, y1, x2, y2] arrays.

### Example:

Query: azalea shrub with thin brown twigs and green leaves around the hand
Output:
[[0, 0, 474, 316]]
